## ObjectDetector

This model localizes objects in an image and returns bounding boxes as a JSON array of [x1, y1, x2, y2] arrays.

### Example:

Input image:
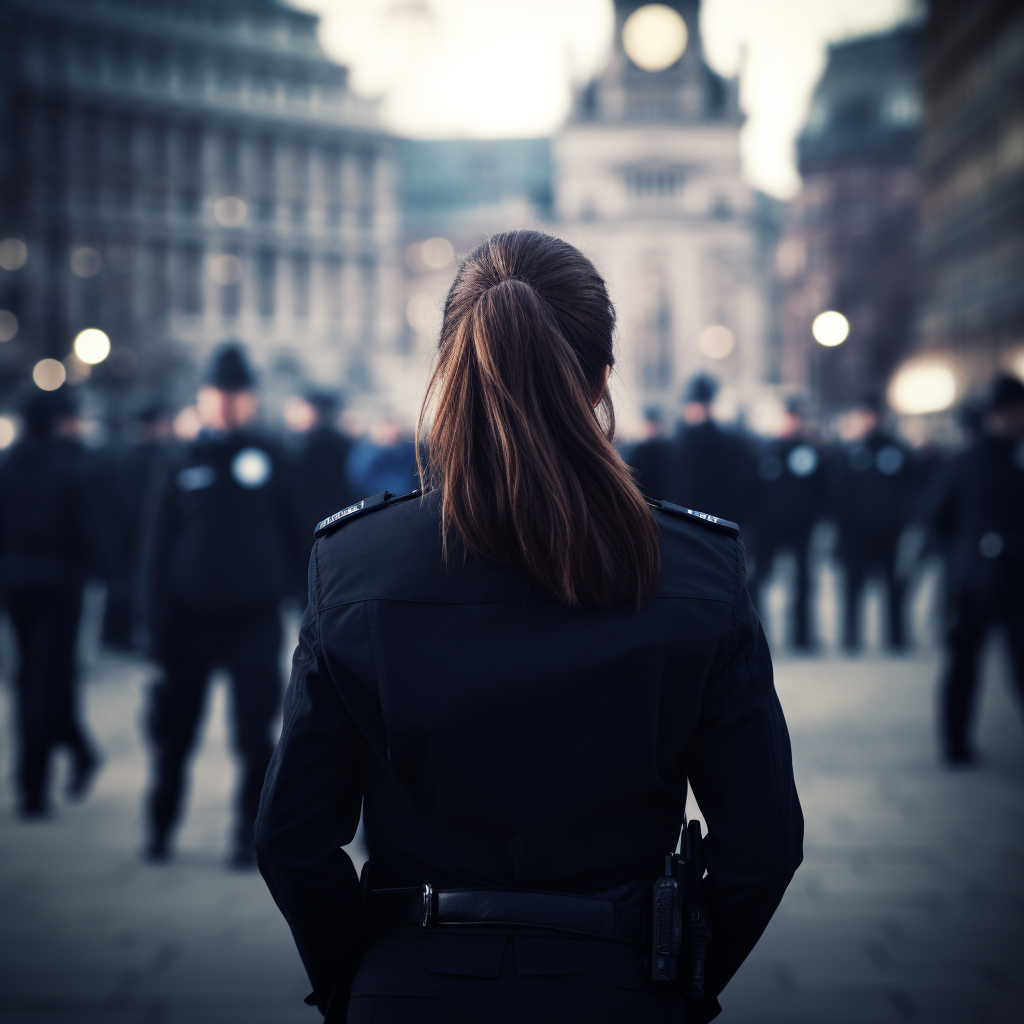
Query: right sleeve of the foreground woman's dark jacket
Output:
[[686, 586, 804, 1020]]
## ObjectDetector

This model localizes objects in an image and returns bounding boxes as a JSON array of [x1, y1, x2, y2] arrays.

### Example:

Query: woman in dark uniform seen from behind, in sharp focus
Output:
[[256, 231, 803, 1024]]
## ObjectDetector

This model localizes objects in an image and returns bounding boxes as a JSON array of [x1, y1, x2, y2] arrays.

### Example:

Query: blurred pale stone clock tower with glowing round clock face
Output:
[[552, 0, 766, 431]]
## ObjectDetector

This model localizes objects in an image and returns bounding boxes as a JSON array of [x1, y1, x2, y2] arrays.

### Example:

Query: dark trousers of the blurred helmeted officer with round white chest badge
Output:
[[147, 608, 281, 850]]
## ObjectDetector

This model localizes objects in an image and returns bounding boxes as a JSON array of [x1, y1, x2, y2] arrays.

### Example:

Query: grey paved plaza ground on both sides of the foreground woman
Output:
[[0, 585, 1024, 1024]]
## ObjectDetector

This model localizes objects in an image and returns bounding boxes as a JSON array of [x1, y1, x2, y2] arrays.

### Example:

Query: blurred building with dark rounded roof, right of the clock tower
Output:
[[776, 28, 923, 408]]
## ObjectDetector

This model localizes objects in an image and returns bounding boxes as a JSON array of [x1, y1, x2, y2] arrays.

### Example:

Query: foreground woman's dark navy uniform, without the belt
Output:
[[256, 494, 803, 1024]]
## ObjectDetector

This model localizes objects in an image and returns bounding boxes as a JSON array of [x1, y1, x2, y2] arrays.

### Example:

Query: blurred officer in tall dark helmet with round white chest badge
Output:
[[142, 344, 305, 867]]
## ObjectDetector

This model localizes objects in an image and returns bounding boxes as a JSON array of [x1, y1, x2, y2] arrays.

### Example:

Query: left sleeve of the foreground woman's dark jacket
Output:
[[256, 554, 365, 1014]]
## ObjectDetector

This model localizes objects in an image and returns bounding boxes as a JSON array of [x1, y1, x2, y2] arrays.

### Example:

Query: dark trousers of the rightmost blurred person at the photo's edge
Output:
[[940, 599, 1024, 758]]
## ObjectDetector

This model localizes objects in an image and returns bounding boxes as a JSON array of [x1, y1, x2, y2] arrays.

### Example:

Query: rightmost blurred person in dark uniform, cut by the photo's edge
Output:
[[923, 377, 1024, 765]]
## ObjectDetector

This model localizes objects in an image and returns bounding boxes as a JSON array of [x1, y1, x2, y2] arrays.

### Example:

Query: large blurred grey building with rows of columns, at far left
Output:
[[0, 0, 400, 407]]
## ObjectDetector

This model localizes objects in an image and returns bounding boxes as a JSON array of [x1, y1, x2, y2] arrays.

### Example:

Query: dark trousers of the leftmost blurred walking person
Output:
[[7, 585, 92, 811]]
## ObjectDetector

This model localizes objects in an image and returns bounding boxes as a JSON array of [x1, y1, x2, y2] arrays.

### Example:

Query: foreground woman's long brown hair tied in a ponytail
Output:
[[417, 231, 660, 608]]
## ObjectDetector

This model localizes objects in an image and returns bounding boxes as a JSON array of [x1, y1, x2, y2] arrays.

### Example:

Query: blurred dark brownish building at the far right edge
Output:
[[918, 0, 1024, 391]]
